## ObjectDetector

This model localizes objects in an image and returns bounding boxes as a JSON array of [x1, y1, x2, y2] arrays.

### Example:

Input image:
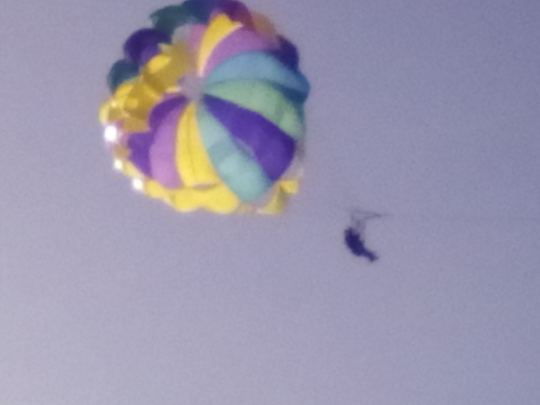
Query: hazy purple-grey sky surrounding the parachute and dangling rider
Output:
[[0, 0, 540, 405]]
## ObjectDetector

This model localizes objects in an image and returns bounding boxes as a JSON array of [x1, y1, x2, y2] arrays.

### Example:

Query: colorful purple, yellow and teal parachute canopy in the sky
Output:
[[100, 0, 309, 214]]
